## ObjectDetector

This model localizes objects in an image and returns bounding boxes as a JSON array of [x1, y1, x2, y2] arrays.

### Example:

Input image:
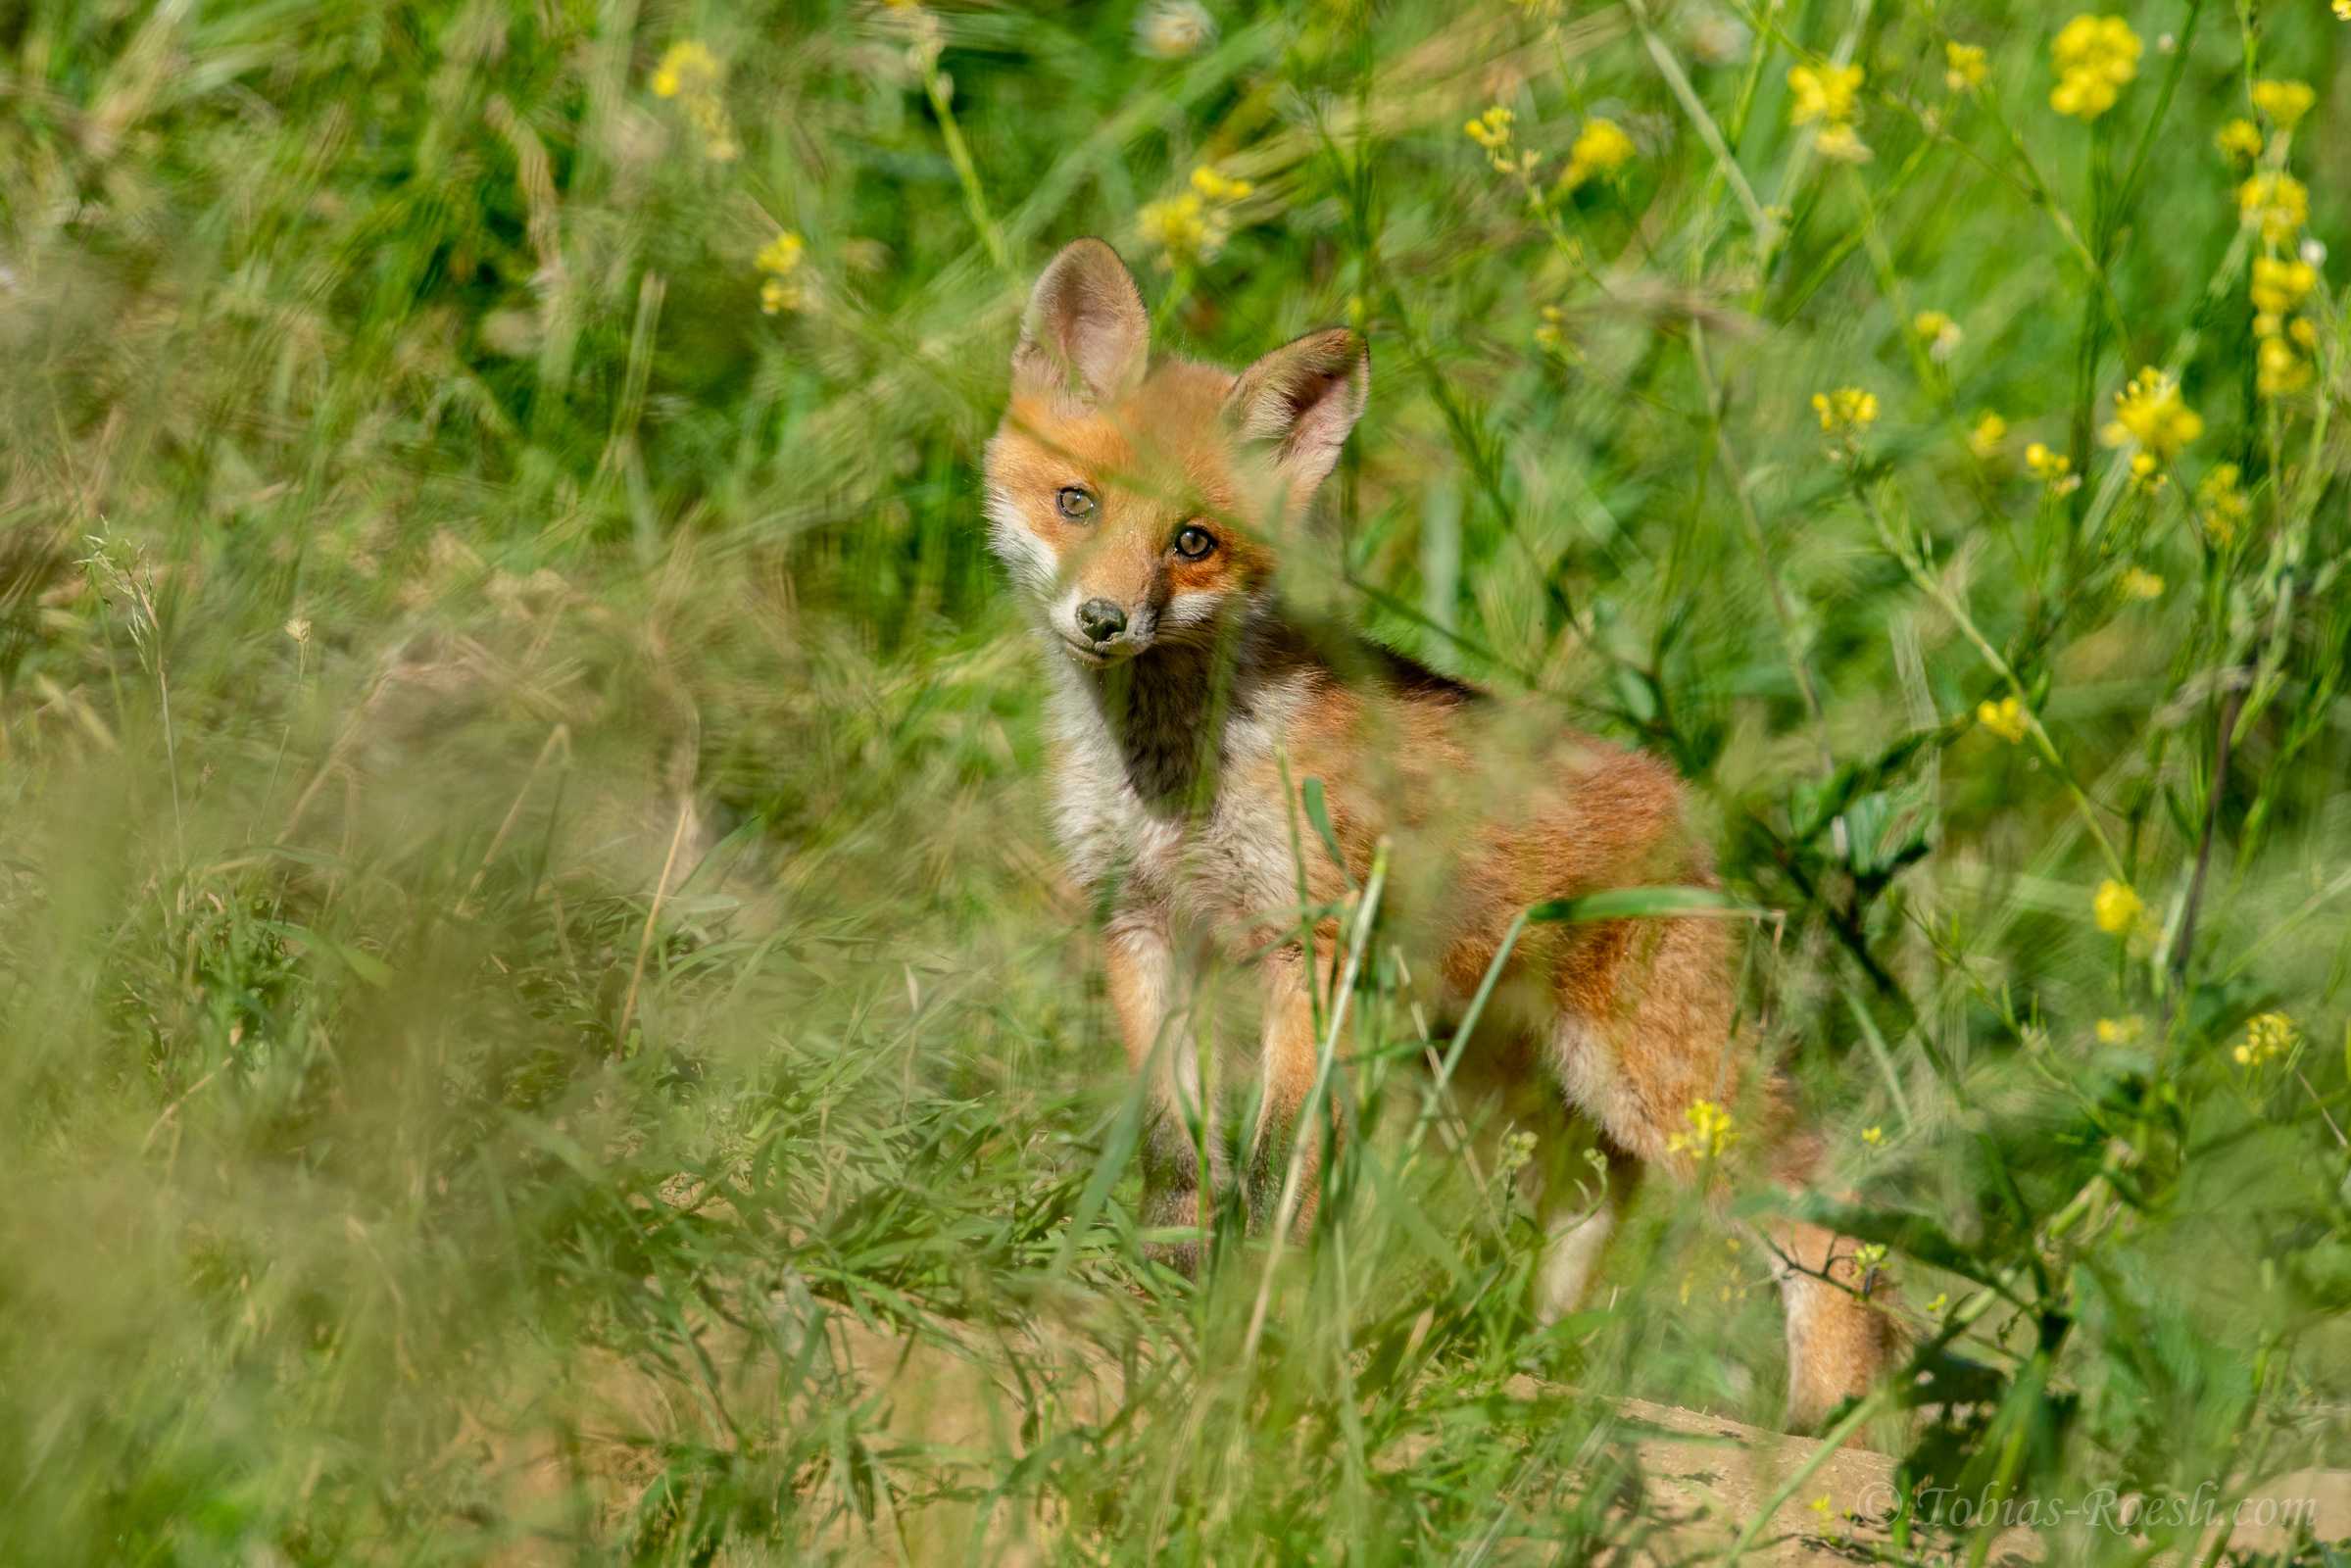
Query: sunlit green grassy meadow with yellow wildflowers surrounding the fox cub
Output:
[[0, 0, 2351, 1568]]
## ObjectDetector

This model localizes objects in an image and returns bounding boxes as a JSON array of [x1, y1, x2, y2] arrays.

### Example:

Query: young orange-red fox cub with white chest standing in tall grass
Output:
[[983, 237, 1899, 1429]]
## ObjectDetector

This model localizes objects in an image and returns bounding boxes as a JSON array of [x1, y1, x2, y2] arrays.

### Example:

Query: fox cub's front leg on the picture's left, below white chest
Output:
[[1107, 912, 1215, 1274]]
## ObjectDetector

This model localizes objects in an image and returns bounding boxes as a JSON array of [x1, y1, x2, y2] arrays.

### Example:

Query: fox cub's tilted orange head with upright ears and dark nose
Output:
[[988, 240, 1371, 667]]
